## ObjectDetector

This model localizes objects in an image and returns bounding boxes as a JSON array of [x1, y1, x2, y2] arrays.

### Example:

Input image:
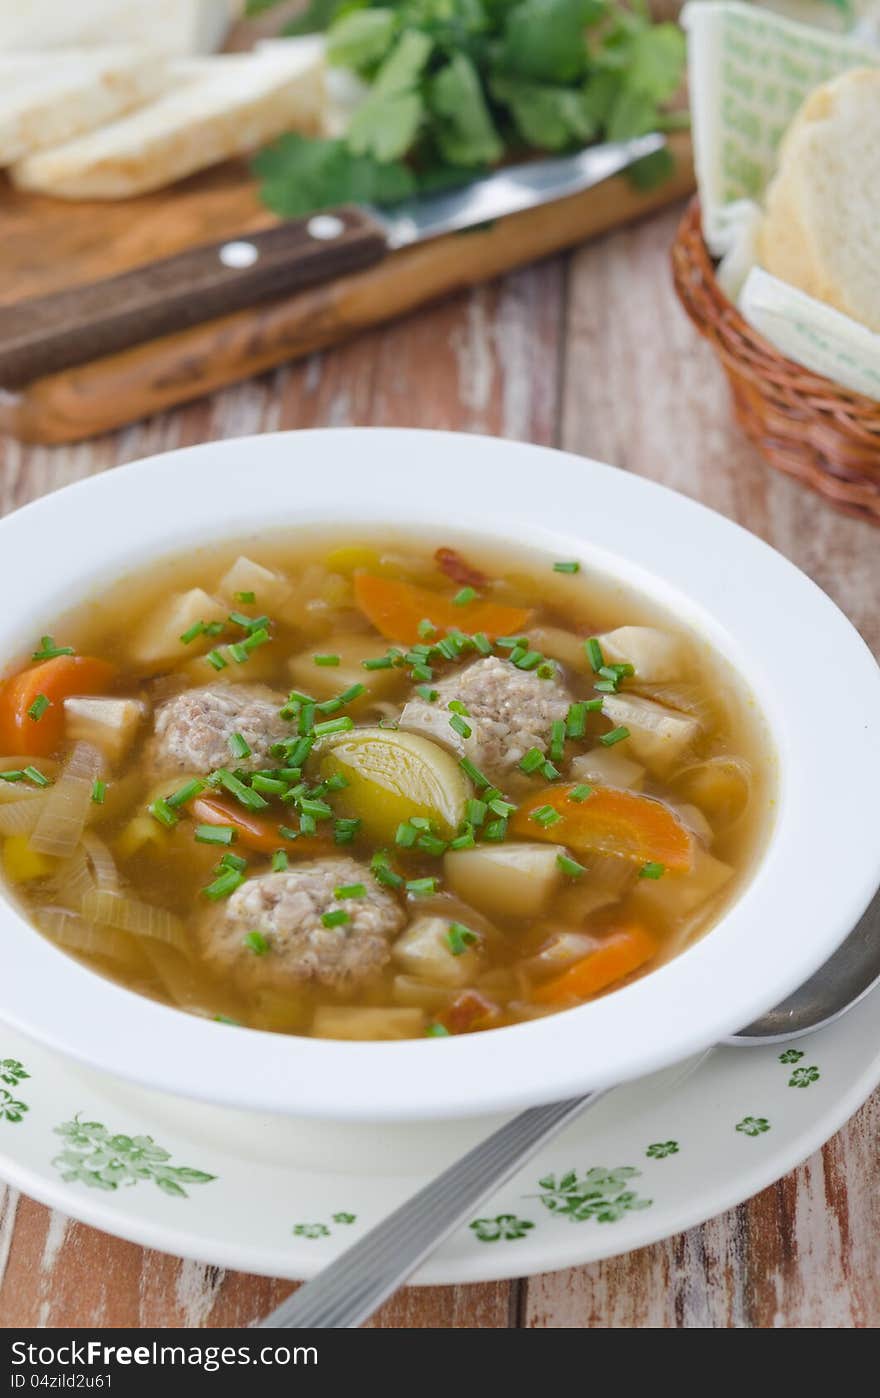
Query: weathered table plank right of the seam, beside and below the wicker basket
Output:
[[514, 199, 880, 1328]]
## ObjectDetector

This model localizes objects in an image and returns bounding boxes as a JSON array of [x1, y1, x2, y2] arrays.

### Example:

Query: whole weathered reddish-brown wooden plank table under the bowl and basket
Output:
[[0, 202, 880, 1328]]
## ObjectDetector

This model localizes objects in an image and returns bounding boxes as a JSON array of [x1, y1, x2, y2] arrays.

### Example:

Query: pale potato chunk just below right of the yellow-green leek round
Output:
[[443, 840, 565, 917]]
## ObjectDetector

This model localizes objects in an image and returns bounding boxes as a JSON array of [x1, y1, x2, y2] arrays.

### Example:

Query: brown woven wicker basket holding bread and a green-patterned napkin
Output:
[[672, 199, 880, 524]]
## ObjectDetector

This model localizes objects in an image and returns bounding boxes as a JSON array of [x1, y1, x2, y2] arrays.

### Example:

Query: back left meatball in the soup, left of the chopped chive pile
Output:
[[147, 685, 292, 773]]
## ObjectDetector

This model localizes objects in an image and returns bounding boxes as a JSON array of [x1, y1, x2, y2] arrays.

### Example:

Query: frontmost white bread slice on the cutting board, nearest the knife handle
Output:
[[11, 49, 323, 199]]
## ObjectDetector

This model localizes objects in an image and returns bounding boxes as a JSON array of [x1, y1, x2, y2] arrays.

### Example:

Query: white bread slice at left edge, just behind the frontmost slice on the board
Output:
[[0, 45, 166, 165]]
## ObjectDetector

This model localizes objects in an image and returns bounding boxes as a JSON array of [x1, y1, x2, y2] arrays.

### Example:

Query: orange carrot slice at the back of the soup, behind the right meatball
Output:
[[354, 573, 532, 646]]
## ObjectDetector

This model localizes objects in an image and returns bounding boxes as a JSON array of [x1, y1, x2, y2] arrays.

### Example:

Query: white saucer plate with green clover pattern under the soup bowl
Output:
[[0, 994, 880, 1283]]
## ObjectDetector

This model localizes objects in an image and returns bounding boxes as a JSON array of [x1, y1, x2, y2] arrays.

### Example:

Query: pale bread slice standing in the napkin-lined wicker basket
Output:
[[758, 67, 880, 331]]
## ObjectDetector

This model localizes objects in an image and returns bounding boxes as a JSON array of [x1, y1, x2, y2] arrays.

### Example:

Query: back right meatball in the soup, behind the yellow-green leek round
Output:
[[400, 656, 571, 776]]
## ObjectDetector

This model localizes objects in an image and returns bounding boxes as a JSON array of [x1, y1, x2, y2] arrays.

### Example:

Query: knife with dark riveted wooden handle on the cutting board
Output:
[[0, 134, 665, 389]]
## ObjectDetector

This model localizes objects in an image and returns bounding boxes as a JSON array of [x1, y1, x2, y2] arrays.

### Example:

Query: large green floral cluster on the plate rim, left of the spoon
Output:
[[52, 1116, 217, 1199]]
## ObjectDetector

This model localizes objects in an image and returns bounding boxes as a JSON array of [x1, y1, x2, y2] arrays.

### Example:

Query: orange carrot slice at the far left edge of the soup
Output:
[[0, 656, 116, 758]]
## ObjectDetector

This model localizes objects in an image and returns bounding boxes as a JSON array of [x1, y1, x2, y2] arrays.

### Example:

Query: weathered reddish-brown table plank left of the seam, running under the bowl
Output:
[[0, 261, 564, 1328]]
